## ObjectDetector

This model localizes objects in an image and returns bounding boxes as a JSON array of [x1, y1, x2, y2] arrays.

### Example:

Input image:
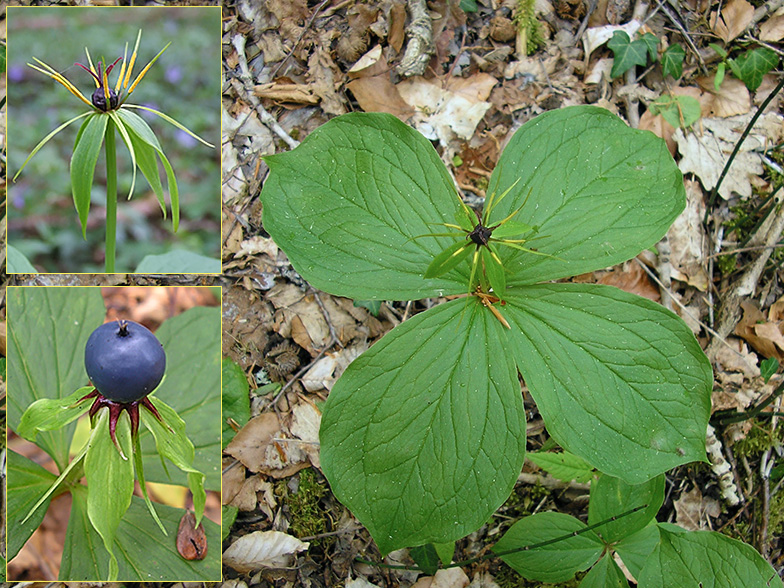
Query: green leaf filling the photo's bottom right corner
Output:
[[639, 523, 784, 588]]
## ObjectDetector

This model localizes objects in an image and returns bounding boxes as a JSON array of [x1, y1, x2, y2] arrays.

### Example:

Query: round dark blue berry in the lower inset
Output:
[[84, 320, 166, 404]]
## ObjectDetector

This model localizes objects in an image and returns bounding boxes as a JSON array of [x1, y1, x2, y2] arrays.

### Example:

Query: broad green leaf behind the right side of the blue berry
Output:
[[139, 307, 221, 490]]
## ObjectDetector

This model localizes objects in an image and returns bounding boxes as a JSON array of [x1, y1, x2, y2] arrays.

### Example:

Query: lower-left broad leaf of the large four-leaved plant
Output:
[[320, 297, 525, 553]]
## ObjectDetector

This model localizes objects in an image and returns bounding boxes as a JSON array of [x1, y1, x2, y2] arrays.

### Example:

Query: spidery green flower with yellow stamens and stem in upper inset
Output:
[[14, 30, 214, 273]]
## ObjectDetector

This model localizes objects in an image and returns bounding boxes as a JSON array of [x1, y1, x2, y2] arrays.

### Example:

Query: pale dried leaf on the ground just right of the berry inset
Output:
[[223, 531, 310, 573]]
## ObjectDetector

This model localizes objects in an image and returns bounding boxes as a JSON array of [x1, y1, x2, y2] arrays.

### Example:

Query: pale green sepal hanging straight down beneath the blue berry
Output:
[[84, 408, 134, 582]]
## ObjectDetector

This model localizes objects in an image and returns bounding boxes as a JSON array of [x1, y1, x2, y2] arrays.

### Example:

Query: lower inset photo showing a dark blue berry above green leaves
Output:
[[6, 287, 221, 582]]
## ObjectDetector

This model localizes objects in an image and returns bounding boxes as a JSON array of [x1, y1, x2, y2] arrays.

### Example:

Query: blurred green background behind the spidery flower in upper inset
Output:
[[7, 7, 221, 273]]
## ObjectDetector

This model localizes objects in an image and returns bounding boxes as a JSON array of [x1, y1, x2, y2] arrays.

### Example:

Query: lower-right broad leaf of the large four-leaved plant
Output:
[[505, 284, 713, 484]]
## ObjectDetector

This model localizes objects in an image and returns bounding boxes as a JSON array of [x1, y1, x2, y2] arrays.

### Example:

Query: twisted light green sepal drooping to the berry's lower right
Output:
[[139, 396, 206, 526]]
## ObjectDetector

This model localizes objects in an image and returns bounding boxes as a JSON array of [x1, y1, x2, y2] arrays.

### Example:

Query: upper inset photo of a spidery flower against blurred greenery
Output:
[[6, 6, 221, 274]]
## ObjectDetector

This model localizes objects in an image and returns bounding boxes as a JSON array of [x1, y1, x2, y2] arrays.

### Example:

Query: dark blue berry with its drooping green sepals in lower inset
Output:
[[17, 316, 206, 581]]
